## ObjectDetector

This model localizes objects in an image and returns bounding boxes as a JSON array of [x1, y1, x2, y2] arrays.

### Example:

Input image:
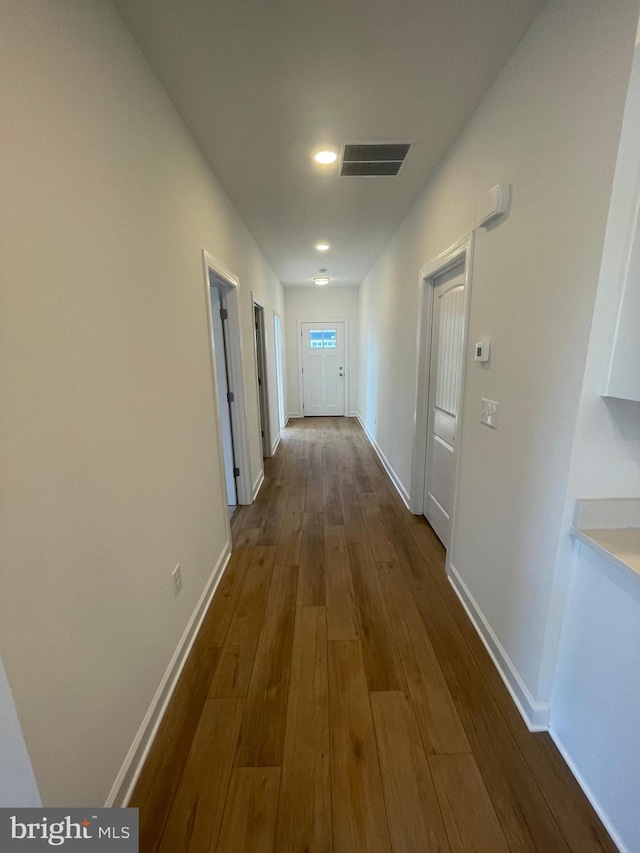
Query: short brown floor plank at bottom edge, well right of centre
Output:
[[429, 755, 509, 853]]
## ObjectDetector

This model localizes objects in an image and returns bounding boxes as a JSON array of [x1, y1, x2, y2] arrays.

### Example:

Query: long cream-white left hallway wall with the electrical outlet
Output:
[[0, 0, 284, 806]]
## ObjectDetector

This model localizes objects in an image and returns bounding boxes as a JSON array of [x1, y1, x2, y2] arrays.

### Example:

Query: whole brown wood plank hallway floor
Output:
[[131, 418, 615, 853]]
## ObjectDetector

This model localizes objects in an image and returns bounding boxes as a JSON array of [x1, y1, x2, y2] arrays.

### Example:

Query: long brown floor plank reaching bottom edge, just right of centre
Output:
[[329, 640, 391, 853]]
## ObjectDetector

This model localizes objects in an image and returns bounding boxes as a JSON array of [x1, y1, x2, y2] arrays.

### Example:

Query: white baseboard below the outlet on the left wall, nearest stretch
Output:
[[105, 542, 231, 808]]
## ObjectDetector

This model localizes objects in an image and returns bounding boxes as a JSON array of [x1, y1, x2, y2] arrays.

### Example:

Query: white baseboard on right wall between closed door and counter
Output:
[[449, 563, 549, 732]]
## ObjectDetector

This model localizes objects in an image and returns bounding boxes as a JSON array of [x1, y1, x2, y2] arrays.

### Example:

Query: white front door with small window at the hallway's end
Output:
[[301, 321, 346, 417]]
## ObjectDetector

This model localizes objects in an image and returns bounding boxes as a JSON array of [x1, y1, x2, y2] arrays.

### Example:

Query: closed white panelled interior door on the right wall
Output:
[[424, 264, 465, 548]]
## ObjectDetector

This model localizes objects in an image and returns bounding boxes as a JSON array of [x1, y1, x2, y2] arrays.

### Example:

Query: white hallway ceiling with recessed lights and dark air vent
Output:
[[115, 0, 543, 286]]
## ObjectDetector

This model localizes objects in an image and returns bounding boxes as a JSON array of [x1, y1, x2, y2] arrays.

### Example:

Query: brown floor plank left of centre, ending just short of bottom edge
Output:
[[235, 566, 298, 767]]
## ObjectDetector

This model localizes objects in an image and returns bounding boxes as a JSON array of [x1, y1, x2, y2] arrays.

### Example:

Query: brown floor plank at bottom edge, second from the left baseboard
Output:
[[156, 697, 244, 853]]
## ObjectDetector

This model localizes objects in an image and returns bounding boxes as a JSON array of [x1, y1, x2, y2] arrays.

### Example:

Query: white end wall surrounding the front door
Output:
[[284, 285, 360, 417]]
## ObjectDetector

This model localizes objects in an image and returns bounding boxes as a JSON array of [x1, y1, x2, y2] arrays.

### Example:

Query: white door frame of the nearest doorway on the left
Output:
[[202, 249, 253, 506]]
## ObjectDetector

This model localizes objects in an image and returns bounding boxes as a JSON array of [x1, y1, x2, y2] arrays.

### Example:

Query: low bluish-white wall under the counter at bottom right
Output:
[[551, 543, 640, 853]]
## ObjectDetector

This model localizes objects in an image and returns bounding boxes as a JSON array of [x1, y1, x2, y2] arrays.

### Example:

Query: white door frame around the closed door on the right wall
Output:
[[409, 231, 475, 573]]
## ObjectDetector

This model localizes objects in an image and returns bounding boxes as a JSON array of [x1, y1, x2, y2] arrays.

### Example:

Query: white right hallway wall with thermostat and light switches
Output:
[[360, 0, 638, 712]]
